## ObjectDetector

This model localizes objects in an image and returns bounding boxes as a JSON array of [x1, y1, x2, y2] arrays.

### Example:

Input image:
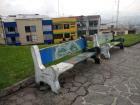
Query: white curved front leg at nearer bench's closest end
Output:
[[42, 67, 60, 93]]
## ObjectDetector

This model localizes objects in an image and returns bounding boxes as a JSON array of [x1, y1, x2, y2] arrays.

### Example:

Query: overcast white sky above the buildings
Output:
[[0, 0, 140, 17]]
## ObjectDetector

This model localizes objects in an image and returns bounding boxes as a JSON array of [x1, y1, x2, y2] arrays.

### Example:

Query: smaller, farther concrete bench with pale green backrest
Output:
[[94, 33, 124, 59]]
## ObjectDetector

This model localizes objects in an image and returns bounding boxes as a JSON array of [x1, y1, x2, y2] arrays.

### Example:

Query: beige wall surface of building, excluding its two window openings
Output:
[[16, 19, 44, 44]]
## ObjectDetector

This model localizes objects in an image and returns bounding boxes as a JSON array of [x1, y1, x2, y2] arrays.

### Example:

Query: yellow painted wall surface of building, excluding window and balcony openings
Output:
[[52, 17, 77, 43]]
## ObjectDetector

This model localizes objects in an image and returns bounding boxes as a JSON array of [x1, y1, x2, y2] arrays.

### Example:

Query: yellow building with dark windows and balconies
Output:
[[52, 17, 77, 43]]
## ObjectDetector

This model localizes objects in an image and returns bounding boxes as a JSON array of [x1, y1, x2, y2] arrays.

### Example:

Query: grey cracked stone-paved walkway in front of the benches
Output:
[[0, 44, 140, 105]]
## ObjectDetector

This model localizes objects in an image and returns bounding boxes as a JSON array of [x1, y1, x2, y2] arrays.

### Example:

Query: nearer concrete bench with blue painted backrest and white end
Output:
[[31, 38, 99, 93]]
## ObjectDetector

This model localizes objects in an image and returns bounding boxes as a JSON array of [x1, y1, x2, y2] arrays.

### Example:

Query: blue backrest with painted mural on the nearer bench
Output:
[[40, 38, 86, 64]]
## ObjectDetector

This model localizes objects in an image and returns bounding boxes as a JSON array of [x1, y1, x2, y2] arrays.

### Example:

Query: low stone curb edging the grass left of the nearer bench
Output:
[[0, 76, 35, 98]]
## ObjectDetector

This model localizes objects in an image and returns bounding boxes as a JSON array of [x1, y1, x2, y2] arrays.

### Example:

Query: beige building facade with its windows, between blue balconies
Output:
[[16, 19, 44, 44]]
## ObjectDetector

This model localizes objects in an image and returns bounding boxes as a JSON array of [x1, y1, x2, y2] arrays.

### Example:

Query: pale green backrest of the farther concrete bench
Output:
[[97, 33, 113, 45]]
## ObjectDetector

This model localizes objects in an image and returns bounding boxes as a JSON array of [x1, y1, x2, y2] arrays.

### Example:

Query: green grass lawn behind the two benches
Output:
[[0, 34, 140, 90]]
